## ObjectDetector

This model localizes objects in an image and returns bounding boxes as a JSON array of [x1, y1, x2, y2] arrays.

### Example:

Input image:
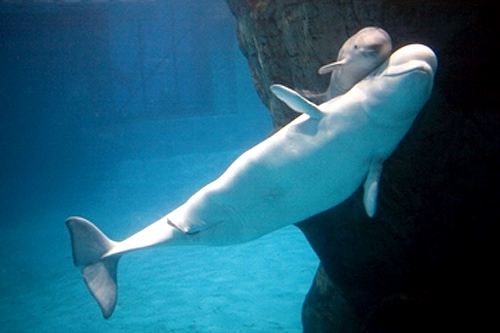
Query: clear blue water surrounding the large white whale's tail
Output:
[[0, 0, 318, 332]]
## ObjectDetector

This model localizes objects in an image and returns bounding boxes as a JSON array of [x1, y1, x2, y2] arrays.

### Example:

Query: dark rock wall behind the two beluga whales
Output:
[[227, 0, 500, 332]]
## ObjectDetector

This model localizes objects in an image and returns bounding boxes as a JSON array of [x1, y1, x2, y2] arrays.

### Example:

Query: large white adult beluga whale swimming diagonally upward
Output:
[[66, 44, 437, 318]]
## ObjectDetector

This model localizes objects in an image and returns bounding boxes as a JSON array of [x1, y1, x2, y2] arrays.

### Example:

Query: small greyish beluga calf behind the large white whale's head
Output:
[[303, 27, 392, 103]]
